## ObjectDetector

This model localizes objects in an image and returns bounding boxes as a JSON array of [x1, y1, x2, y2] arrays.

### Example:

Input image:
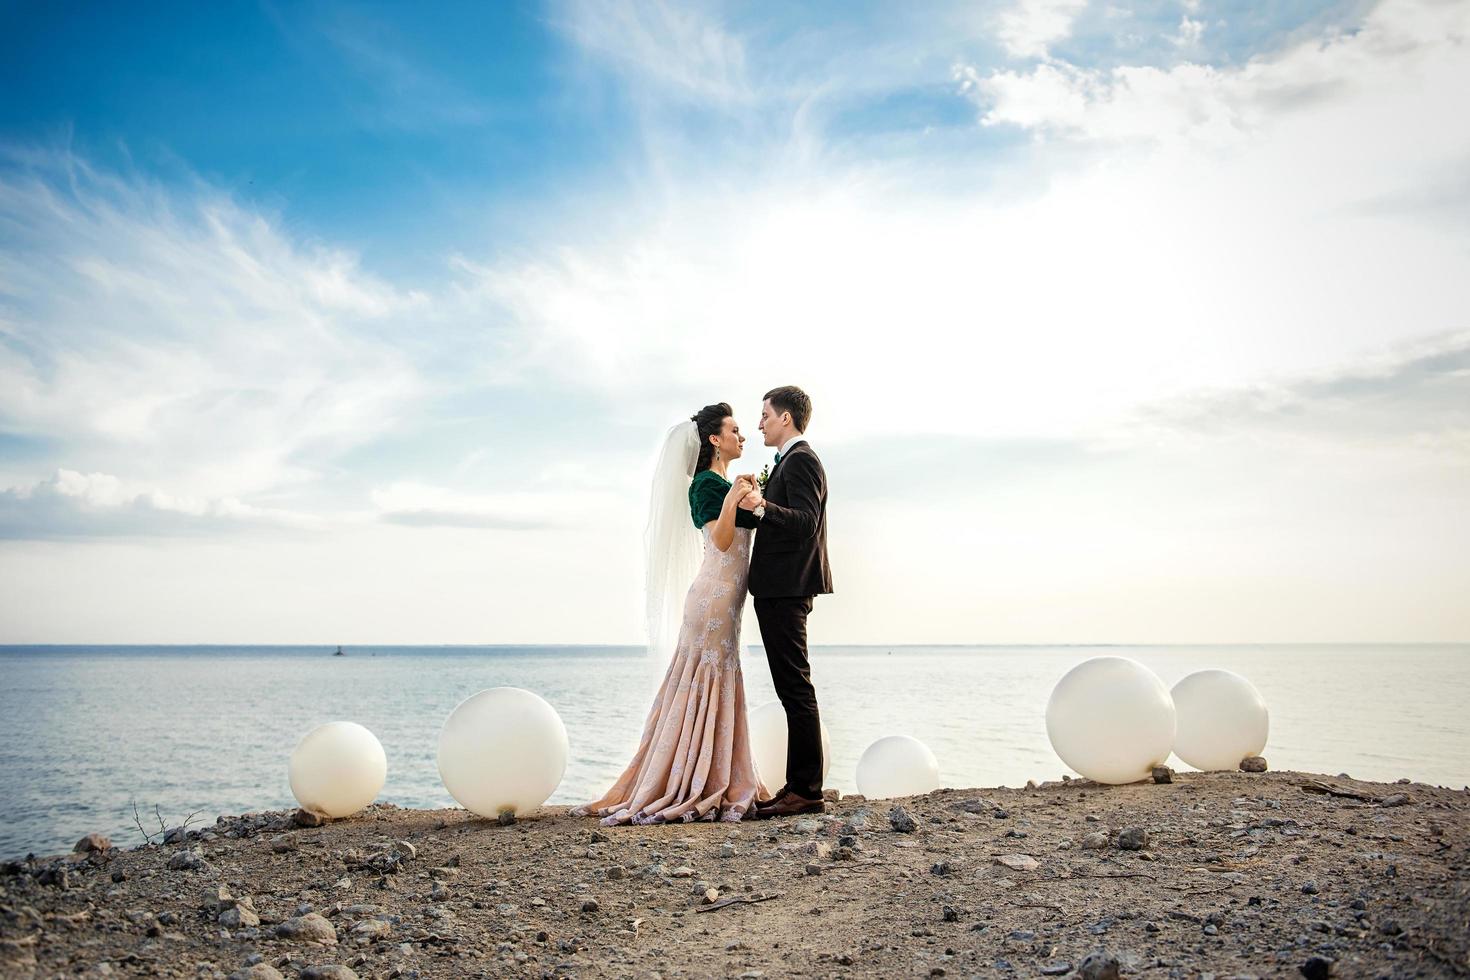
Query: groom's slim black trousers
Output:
[[756, 595, 822, 799]]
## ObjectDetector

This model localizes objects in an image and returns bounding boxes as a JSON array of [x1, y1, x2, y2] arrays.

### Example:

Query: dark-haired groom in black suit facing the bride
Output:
[[739, 385, 832, 818]]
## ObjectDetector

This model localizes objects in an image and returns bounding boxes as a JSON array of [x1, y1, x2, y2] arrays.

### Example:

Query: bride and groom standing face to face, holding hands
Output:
[[572, 385, 832, 826]]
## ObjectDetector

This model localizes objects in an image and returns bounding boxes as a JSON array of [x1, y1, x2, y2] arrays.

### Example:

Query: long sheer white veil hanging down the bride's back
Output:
[[644, 420, 704, 688]]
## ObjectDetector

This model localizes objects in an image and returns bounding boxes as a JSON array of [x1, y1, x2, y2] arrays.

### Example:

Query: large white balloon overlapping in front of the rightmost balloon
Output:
[[1047, 657, 1175, 783]]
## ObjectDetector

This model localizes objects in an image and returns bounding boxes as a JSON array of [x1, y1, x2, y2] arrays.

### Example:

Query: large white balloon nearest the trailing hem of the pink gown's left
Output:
[[440, 688, 567, 817]]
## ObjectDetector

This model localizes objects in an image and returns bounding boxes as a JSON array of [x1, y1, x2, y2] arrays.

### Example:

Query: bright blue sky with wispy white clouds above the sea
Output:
[[0, 0, 1470, 645]]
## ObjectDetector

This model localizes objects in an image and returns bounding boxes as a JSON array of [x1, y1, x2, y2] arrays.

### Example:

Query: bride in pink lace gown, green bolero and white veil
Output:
[[572, 403, 770, 824]]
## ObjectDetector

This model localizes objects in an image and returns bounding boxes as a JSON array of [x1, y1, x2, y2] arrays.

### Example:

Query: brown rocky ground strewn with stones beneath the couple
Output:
[[0, 773, 1470, 980]]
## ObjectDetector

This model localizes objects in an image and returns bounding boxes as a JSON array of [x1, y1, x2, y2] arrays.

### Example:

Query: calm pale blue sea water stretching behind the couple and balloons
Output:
[[0, 645, 1470, 857]]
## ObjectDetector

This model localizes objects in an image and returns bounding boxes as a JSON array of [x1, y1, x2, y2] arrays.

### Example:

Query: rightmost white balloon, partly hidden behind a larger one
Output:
[[1173, 670, 1270, 770]]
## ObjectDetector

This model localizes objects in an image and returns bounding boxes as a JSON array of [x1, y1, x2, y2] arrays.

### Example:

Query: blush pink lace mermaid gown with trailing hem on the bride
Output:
[[572, 517, 769, 826]]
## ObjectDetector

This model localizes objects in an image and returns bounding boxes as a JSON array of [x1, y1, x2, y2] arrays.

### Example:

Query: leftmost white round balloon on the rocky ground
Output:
[[288, 721, 388, 817]]
